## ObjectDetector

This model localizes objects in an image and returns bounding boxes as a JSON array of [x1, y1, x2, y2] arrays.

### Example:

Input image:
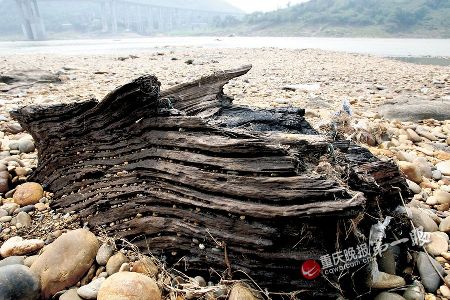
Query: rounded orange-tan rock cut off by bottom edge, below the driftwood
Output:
[[97, 272, 161, 300]]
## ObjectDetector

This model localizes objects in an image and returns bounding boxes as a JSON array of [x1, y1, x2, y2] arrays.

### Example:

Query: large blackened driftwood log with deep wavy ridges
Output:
[[12, 66, 412, 294]]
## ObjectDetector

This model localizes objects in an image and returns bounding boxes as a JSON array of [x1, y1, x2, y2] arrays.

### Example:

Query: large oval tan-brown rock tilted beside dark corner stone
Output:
[[31, 229, 99, 299]]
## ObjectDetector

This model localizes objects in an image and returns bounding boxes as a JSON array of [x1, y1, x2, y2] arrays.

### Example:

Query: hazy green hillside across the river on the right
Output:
[[227, 0, 450, 38]]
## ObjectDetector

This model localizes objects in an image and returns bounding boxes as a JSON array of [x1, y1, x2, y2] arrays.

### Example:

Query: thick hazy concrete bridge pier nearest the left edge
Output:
[[16, 0, 45, 41]]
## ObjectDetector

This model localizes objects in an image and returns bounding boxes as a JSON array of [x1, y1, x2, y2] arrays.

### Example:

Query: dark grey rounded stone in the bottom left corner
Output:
[[0, 264, 40, 300]]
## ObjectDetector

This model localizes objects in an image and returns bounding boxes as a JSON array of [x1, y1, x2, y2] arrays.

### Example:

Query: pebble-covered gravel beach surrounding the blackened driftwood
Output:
[[0, 47, 450, 300]]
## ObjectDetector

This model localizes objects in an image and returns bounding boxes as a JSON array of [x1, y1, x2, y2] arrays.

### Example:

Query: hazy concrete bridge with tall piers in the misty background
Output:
[[16, 0, 242, 40]]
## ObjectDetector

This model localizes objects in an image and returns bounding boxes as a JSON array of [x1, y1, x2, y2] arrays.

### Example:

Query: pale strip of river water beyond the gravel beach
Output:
[[0, 37, 450, 57]]
